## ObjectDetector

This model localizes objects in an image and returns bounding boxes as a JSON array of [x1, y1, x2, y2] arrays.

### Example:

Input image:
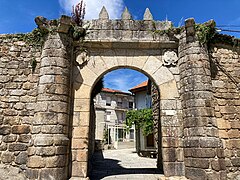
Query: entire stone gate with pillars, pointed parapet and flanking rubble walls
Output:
[[0, 8, 240, 180]]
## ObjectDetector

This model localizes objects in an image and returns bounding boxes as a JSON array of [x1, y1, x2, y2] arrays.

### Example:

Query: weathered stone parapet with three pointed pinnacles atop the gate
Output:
[[84, 7, 175, 42]]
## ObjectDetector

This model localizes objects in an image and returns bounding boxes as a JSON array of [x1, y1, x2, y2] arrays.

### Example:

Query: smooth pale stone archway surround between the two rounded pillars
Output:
[[71, 48, 184, 178]]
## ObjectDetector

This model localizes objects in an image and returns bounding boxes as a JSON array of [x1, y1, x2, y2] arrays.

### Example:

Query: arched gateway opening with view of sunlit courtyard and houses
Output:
[[88, 67, 163, 179]]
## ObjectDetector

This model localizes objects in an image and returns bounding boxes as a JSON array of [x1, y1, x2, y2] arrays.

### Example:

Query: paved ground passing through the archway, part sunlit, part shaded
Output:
[[90, 149, 165, 180]]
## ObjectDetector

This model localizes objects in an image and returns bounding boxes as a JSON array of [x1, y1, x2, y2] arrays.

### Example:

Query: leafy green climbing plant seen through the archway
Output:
[[125, 108, 154, 136]]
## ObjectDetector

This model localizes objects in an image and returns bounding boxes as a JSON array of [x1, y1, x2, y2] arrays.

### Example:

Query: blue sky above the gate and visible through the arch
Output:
[[0, 0, 240, 91]]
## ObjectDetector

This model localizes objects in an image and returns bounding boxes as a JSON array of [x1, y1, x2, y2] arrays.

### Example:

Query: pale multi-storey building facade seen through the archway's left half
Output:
[[94, 88, 135, 149]]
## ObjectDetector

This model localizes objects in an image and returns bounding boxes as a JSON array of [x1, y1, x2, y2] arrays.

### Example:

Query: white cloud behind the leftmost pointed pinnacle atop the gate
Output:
[[59, 0, 124, 19]]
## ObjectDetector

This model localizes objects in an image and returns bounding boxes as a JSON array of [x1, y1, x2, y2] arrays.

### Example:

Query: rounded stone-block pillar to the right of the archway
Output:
[[179, 19, 225, 180]]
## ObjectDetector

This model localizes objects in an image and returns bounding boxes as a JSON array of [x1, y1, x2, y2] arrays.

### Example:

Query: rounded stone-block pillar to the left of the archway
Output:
[[27, 33, 72, 180]]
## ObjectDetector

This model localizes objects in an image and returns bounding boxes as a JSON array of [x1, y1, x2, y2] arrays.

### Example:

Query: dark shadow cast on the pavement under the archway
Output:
[[89, 151, 163, 180]]
